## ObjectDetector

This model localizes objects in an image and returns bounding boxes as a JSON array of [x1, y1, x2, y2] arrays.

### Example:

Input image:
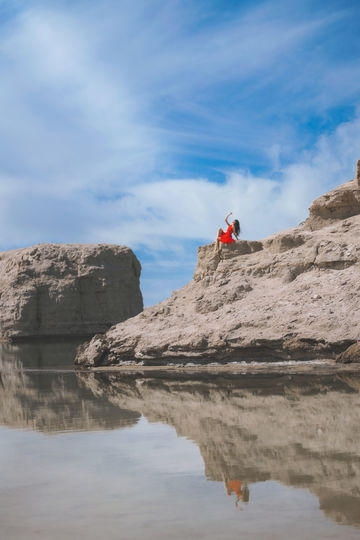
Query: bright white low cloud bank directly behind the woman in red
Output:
[[87, 118, 360, 249]]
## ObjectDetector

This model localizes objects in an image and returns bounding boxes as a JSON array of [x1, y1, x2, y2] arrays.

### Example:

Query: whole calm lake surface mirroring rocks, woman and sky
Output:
[[0, 343, 360, 540]]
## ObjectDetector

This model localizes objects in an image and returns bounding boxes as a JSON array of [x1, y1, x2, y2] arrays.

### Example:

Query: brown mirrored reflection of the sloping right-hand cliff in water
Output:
[[78, 373, 360, 526]]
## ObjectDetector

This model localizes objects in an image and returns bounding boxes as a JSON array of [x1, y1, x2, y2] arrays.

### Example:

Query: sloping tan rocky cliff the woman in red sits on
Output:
[[76, 167, 360, 366]]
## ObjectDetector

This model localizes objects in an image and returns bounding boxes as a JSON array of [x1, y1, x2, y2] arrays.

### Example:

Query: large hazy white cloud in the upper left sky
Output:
[[0, 5, 159, 194]]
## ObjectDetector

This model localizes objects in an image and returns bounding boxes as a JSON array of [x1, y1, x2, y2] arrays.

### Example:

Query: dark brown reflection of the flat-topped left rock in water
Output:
[[0, 356, 139, 433]]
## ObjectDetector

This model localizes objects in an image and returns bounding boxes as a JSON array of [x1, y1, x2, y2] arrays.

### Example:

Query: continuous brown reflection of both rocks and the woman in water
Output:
[[0, 342, 360, 526]]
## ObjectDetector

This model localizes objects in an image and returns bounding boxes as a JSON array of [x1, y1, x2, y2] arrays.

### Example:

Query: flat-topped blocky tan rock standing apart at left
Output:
[[0, 244, 143, 339]]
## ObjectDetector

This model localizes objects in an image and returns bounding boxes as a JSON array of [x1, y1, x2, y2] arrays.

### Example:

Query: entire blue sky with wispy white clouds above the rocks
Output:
[[0, 0, 360, 304]]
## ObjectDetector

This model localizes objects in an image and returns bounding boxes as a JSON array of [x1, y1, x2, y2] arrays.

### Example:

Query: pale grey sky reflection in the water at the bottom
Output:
[[0, 418, 358, 540]]
